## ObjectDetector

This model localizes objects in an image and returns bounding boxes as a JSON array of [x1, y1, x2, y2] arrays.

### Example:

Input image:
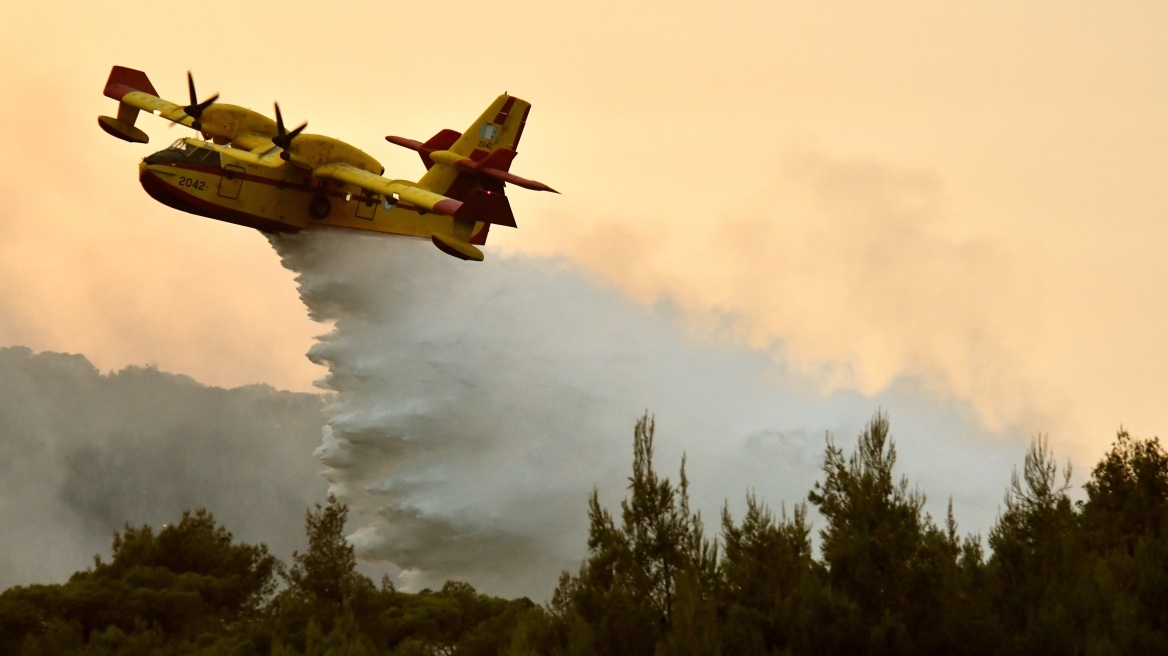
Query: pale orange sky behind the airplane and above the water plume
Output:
[[0, 0, 1168, 462]]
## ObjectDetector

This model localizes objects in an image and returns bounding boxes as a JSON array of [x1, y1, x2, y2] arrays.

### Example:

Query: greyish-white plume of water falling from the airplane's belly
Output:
[[272, 232, 1018, 598]]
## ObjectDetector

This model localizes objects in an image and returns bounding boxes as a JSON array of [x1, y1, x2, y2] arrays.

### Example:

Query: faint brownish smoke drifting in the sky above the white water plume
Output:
[[520, 148, 1051, 434]]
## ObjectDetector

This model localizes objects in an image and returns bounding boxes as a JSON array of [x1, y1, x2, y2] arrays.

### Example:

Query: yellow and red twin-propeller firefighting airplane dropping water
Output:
[[97, 67, 557, 261]]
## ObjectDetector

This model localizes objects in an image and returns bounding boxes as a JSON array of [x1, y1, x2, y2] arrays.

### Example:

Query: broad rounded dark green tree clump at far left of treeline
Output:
[[0, 510, 277, 654]]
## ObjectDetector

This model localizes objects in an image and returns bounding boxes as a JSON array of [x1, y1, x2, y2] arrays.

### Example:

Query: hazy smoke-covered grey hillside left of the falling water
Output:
[[0, 347, 324, 589]]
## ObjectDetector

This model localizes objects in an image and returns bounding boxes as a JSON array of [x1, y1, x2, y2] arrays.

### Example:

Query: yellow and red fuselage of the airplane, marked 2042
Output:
[[138, 139, 487, 244]]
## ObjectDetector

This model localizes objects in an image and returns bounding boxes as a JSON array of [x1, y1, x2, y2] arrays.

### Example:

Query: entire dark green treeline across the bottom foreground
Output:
[[0, 414, 1168, 656]]
